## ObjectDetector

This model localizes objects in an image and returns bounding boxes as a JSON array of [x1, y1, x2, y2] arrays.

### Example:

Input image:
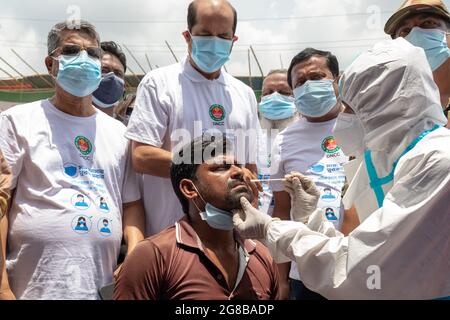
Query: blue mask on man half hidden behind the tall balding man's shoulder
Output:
[[259, 92, 295, 120]]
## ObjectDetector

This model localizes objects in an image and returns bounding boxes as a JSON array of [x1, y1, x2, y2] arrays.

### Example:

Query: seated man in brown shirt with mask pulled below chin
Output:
[[114, 135, 278, 300]]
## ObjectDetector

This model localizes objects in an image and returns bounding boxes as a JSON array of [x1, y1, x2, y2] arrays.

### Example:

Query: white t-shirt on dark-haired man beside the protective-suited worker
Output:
[[271, 118, 348, 280]]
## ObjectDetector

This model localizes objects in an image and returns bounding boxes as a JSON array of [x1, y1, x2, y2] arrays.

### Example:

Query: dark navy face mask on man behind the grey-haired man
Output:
[[92, 72, 125, 108]]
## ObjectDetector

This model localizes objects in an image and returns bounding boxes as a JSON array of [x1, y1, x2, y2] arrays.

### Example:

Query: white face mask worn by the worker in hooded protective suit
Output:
[[333, 113, 364, 158]]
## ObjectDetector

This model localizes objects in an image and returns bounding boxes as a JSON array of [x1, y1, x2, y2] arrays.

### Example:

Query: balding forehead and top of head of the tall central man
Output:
[[187, 0, 237, 34]]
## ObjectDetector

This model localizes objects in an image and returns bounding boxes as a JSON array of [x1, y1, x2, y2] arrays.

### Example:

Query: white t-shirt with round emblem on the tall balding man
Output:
[[126, 58, 260, 236]]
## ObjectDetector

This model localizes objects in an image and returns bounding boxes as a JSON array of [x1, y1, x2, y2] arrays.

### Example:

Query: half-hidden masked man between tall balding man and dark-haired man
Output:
[[258, 69, 299, 215]]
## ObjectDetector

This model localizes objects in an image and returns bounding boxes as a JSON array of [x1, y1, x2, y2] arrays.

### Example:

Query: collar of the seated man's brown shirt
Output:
[[175, 217, 256, 257]]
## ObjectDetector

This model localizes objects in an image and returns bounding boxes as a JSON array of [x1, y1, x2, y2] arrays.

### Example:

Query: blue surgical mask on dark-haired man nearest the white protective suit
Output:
[[294, 79, 337, 118]]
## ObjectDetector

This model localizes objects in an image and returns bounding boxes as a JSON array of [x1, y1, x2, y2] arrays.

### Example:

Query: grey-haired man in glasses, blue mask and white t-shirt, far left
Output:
[[0, 21, 145, 300]]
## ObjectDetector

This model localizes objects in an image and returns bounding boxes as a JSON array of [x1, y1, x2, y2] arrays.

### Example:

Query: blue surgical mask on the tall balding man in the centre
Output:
[[191, 35, 233, 73]]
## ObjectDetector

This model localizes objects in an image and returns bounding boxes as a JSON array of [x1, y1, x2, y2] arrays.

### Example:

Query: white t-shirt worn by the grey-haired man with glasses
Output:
[[0, 100, 140, 300]]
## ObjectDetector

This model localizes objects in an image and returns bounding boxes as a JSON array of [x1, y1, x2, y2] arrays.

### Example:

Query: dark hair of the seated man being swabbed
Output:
[[170, 134, 230, 214]]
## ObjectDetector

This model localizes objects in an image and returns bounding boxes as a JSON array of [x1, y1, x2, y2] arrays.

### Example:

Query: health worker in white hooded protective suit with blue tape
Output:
[[234, 38, 450, 299]]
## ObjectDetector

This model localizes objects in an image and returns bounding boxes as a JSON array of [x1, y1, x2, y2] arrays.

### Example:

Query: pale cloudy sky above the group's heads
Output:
[[0, 0, 450, 77]]
